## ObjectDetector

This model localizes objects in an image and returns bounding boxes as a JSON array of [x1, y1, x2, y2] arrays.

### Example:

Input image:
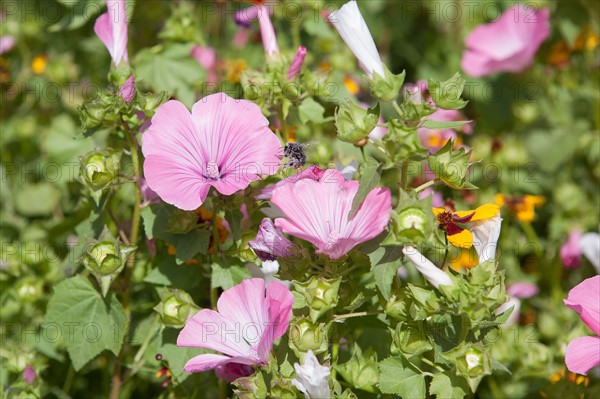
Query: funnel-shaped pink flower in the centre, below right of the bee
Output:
[[271, 169, 392, 259]]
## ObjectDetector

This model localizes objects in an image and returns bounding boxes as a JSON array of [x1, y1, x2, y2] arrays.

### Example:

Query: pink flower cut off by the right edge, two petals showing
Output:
[[564, 276, 600, 375]]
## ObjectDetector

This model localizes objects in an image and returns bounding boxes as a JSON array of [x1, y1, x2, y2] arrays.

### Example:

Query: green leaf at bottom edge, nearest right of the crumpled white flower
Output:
[[379, 357, 426, 399]]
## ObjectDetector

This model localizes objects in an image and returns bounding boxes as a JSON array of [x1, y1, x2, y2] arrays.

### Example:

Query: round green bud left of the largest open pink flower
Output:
[[80, 148, 121, 191]]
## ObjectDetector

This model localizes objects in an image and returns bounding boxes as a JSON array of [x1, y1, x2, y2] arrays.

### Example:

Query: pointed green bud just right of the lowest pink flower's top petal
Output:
[[295, 277, 342, 322]]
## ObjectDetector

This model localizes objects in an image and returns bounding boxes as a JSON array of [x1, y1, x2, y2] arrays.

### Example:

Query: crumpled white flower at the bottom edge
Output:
[[292, 350, 331, 399]]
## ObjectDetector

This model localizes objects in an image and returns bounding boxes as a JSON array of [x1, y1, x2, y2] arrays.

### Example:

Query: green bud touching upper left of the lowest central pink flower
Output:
[[154, 288, 199, 328]]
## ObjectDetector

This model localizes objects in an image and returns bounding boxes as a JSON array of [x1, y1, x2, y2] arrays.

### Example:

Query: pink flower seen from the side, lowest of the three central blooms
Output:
[[177, 278, 294, 381]]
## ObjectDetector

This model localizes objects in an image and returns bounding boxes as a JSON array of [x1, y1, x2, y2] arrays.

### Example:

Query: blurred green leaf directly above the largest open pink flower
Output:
[[134, 43, 205, 107]]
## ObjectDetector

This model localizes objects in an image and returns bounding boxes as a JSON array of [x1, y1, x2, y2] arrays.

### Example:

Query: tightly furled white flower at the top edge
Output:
[[329, 0, 385, 79]]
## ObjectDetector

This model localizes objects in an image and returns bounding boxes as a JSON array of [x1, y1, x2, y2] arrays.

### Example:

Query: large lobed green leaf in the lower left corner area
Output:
[[44, 276, 127, 371]]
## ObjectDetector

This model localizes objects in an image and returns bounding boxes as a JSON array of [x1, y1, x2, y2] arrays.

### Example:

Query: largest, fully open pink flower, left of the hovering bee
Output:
[[142, 93, 282, 210]]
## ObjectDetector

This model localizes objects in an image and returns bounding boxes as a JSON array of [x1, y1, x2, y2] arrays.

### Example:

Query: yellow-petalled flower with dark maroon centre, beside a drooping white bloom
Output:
[[433, 204, 500, 249]]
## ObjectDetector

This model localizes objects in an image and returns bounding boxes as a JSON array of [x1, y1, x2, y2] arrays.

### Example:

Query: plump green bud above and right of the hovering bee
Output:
[[335, 101, 379, 143]]
